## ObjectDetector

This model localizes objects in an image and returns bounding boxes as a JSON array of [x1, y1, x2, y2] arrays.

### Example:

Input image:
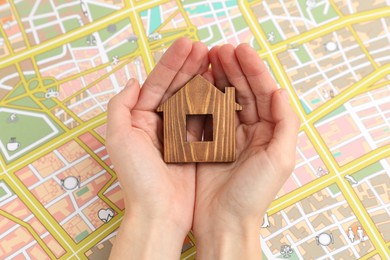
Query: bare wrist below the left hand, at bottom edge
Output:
[[110, 215, 187, 259]]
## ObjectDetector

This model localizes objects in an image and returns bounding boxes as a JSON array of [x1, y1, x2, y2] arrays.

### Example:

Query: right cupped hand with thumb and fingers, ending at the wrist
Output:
[[193, 44, 300, 245]]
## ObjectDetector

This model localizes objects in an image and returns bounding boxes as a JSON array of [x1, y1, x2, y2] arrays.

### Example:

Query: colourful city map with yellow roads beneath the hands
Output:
[[0, 0, 390, 259]]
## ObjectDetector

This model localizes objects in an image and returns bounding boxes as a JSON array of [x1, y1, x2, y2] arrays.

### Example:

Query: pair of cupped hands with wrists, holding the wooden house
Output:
[[106, 38, 299, 259]]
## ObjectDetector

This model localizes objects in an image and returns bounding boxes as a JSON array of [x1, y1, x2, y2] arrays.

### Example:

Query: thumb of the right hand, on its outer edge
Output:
[[268, 89, 300, 174]]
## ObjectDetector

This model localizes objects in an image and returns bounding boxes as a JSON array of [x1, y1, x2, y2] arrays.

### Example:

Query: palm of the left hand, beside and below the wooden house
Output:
[[118, 110, 195, 227]]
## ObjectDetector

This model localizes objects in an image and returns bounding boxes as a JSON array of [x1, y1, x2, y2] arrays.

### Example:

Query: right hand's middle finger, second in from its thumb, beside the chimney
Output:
[[218, 45, 259, 124]]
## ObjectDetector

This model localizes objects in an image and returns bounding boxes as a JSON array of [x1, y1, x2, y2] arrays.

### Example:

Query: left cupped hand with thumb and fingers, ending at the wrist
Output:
[[106, 38, 209, 258]]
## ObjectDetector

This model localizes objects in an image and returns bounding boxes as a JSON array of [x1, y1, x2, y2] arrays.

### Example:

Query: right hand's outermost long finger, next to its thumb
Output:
[[236, 43, 277, 122]]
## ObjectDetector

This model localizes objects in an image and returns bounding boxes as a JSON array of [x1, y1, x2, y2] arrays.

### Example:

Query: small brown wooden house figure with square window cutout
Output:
[[157, 75, 242, 163]]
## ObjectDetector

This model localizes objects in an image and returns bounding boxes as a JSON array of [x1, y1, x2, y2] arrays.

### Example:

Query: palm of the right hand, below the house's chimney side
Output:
[[195, 120, 273, 221]]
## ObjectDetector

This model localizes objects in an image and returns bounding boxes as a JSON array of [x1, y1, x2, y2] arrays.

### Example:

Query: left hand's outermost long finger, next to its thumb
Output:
[[136, 38, 192, 110]]
